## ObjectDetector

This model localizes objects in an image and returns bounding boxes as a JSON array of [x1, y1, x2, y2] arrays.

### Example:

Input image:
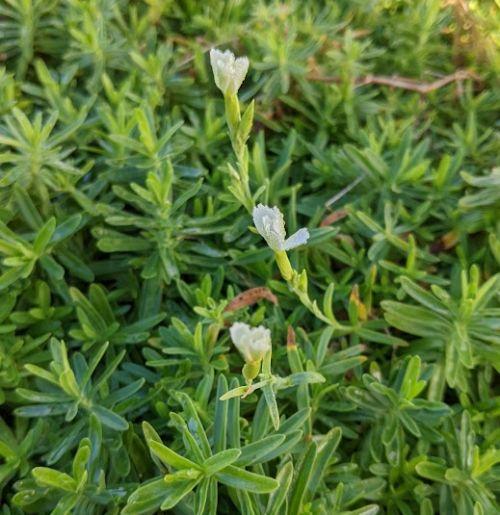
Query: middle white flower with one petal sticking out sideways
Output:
[[252, 204, 309, 252]]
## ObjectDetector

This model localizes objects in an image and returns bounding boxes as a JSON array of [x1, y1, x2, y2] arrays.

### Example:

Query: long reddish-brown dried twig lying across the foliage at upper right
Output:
[[308, 70, 480, 95]]
